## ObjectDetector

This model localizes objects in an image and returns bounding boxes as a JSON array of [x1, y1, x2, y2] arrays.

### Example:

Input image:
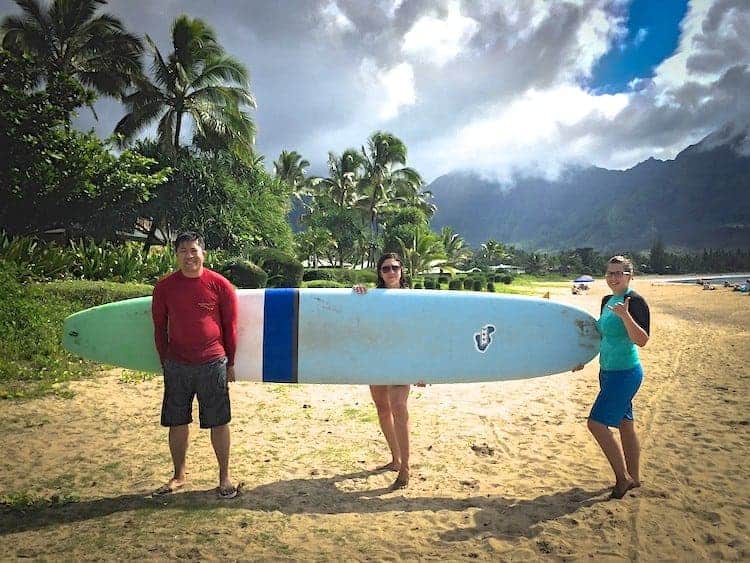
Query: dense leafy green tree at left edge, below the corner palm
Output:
[[0, 49, 170, 239]]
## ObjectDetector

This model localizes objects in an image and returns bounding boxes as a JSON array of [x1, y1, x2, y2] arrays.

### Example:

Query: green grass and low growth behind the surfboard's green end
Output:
[[0, 270, 152, 399]]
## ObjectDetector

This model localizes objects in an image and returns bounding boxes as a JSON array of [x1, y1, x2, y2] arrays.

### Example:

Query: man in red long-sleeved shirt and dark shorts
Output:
[[151, 232, 237, 498]]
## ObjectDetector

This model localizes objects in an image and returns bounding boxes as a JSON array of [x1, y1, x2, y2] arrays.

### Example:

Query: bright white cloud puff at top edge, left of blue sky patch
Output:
[[401, 2, 479, 66]]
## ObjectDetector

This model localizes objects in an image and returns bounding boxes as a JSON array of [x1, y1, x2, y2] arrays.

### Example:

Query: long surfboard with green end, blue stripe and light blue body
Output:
[[63, 289, 599, 384]]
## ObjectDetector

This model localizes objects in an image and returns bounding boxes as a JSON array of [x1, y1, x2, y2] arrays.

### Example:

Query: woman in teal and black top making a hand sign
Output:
[[574, 256, 651, 499]]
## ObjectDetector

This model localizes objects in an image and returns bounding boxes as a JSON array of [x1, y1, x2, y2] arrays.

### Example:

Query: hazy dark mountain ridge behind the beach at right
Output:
[[429, 126, 750, 251]]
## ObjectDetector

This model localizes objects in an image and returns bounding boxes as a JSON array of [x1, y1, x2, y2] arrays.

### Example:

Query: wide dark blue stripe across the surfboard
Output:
[[263, 288, 299, 383]]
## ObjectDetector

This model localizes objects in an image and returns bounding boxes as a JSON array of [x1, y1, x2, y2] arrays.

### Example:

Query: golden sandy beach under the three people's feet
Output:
[[0, 278, 750, 561]]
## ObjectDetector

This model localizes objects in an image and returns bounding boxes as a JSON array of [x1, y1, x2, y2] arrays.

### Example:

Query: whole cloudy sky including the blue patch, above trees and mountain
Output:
[[0, 0, 750, 182]]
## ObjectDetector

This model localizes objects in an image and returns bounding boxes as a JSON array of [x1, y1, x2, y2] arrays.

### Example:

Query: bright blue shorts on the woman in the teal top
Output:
[[589, 364, 643, 426]]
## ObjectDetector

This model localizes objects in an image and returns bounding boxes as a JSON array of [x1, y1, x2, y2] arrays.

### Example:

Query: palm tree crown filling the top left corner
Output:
[[0, 0, 143, 96]]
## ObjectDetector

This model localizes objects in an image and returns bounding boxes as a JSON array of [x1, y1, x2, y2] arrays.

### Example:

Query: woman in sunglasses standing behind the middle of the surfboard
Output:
[[354, 252, 423, 489]]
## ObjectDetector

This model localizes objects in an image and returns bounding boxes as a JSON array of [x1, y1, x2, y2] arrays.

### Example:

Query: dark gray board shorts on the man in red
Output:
[[161, 357, 232, 428]]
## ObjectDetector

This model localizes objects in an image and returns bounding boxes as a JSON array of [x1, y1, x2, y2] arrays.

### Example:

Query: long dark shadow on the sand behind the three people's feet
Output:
[[0, 471, 609, 541]]
